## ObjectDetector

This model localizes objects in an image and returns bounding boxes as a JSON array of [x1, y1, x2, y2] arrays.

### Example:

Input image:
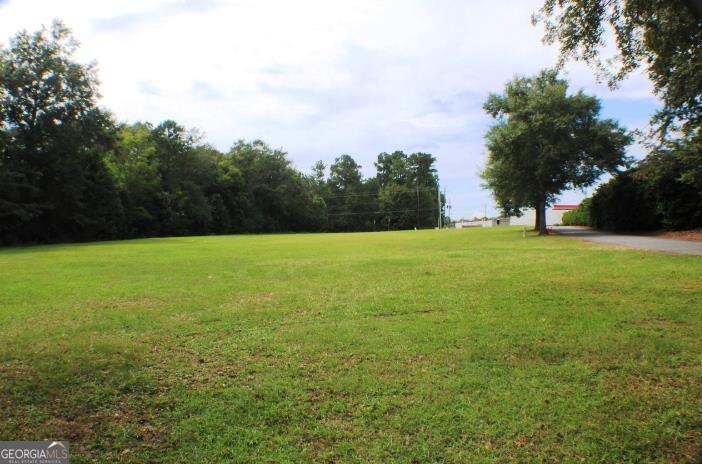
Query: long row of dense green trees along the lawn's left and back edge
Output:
[[0, 21, 443, 244]]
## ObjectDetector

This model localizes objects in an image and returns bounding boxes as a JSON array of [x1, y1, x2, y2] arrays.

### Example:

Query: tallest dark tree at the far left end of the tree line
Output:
[[0, 23, 121, 241]]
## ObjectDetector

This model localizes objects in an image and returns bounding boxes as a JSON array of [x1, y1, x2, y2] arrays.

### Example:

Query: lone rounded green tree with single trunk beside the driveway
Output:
[[482, 70, 631, 233]]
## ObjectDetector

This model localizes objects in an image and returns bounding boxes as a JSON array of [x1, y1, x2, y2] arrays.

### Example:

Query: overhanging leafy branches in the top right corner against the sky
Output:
[[533, 0, 702, 134]]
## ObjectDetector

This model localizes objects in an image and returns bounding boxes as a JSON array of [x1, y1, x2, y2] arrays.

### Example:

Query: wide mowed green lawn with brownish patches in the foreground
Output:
[[0, 228, 702, 463]]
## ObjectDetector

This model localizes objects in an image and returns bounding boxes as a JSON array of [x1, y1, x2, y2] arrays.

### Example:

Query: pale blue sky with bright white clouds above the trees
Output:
[[0, 0, 659, 218]]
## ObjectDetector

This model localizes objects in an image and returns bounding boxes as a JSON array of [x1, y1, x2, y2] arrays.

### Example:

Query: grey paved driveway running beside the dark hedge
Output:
[[553, 226, 702, 256]]
